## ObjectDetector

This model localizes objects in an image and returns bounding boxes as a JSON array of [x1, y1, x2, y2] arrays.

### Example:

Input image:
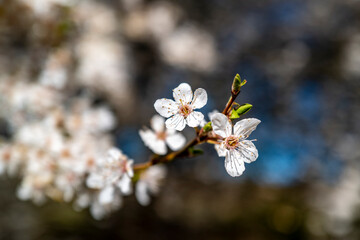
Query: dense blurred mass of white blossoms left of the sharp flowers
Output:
[[0, 79, 166, 219]]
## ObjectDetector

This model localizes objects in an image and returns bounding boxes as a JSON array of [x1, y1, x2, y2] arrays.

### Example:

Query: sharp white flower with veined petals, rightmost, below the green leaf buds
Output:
[[211, 113, 260, 177]]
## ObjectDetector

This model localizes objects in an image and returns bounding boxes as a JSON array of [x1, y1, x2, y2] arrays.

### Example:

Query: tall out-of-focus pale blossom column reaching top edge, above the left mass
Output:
[[74, 1, 132, 111]]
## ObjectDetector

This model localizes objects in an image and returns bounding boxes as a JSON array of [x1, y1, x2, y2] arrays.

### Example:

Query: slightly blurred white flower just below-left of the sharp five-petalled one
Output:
[[139, 115, 186, 155]]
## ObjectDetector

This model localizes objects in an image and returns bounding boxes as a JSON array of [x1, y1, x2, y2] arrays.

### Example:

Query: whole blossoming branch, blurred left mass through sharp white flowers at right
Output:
[[0, 78, 260, 219]]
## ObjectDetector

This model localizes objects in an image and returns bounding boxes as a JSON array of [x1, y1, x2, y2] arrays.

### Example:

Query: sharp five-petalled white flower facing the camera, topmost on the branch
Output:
[[154, 83, 207, 131]]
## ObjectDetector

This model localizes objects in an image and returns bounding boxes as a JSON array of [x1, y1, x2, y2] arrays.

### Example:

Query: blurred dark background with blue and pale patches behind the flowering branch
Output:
[[0, 0, 360, 240]]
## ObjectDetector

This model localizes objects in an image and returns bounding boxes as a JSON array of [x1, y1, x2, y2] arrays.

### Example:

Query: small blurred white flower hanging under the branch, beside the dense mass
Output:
[[135, 165, 166, 206]]
